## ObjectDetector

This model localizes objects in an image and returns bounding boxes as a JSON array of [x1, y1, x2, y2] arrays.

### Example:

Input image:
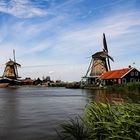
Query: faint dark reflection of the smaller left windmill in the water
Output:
[[0, 89, 19, 140]]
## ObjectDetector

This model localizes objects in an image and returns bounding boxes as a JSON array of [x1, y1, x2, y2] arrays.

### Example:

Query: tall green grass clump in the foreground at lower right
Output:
[[59, 102, 140, 140]]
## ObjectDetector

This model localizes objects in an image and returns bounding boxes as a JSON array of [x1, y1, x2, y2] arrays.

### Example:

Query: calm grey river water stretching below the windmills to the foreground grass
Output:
[[0, 87, 140, 140]]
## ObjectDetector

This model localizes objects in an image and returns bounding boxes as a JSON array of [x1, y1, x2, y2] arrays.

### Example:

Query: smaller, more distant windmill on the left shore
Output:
[[2, 50, 21, 80]]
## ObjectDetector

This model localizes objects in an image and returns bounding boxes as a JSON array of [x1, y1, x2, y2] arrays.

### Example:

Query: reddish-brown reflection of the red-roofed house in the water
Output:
[[83, 90, 140, 103]]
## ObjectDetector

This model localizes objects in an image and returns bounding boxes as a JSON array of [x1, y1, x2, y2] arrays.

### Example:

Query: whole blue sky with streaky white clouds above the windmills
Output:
[[0, 0, 140, 81]]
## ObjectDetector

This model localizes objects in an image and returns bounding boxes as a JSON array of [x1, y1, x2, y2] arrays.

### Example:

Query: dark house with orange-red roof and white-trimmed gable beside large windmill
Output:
[[99, 67, 140, 85]]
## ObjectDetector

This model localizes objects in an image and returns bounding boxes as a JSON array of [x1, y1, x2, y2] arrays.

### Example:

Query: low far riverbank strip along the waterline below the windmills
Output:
[[0, 82, 140, 93]]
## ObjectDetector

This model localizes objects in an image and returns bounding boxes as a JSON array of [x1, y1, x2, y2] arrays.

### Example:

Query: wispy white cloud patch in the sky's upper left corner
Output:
[[0, 0, 47, 18]]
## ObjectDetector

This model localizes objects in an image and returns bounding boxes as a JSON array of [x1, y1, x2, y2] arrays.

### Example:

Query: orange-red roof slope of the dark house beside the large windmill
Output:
[[99, 68, 132, 79]]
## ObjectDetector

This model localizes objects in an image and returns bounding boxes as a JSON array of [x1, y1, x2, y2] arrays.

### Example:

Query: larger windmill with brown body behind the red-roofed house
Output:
[[85, 33, 114, 83]]
